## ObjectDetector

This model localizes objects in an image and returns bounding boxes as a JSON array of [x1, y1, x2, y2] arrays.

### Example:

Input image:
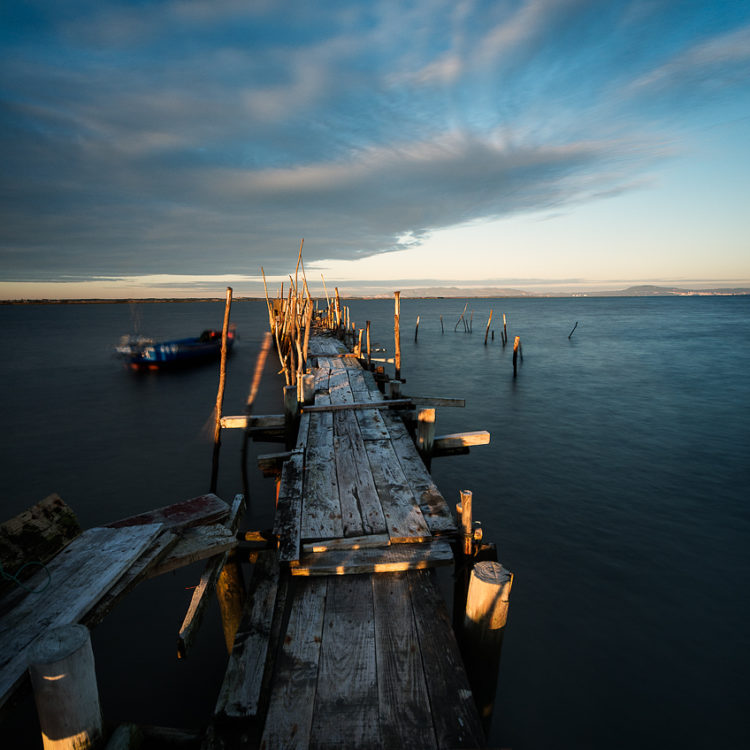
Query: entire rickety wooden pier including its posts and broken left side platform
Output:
[[0, 283, 512, 750]]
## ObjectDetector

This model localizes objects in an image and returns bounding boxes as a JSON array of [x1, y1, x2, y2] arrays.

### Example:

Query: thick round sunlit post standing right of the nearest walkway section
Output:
[[462, 562, 513, 732]]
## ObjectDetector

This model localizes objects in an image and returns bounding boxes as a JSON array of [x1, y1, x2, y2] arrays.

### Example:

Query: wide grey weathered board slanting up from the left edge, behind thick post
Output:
[[0, 524, 163, 705]]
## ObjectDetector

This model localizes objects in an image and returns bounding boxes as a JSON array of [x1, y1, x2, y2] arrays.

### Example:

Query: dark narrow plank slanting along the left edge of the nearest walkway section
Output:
[[214, 550, 279, 719]]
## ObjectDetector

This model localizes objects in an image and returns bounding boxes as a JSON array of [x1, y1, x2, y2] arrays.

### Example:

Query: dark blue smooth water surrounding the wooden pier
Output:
[[0, 297, 750, 750]]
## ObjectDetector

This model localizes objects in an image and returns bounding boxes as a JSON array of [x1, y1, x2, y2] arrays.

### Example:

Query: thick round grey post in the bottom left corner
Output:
[[29, 625, 102, 750]]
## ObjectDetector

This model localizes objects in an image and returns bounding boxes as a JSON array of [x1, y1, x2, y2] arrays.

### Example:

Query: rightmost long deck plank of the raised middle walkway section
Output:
[[383, 413, 457, 534]]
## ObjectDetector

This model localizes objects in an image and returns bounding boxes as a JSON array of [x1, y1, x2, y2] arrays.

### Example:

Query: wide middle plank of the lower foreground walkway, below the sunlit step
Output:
[[310, 576, 382, 750]]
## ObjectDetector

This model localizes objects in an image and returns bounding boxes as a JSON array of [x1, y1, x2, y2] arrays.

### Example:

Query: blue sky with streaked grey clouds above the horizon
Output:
[[0, 0, 750, 299]]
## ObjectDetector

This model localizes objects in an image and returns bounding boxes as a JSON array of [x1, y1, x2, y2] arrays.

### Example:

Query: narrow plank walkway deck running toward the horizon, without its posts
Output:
[[214, 336, 484, 750]]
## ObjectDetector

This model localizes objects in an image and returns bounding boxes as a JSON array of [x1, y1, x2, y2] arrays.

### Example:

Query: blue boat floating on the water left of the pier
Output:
[[116, 327, 235, 370]]
